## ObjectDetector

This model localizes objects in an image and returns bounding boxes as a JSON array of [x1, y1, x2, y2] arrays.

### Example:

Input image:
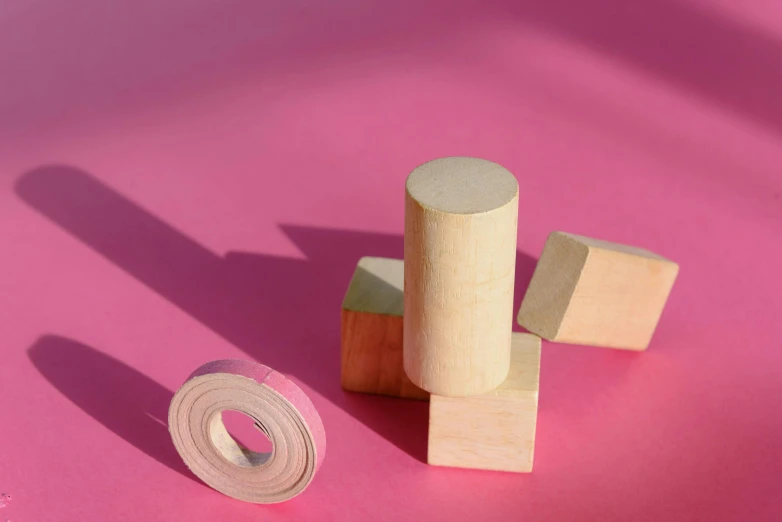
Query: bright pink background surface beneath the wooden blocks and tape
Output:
[[0, 0, 782, 522]]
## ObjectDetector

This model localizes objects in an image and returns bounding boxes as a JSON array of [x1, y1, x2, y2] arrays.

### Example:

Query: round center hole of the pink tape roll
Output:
[[210, 410, 274, 467]]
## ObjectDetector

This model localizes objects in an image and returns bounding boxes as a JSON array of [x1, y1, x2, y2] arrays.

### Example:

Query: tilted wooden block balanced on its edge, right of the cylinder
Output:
[[518, 232, 679, 350]]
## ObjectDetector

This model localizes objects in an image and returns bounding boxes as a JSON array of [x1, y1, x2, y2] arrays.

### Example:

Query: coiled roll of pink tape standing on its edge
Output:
[[168, 360, 326, 504]]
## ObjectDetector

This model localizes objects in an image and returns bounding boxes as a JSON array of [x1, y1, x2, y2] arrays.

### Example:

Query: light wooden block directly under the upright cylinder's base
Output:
[[427, 333, 540, 472]]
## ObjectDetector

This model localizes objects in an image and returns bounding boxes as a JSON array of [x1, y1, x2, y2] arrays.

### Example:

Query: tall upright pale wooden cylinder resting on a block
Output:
[[403, 158, 519, 397]]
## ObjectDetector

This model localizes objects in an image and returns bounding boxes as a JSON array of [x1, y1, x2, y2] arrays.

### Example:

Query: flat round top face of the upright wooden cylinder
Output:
[[406, 157, 519, 214]]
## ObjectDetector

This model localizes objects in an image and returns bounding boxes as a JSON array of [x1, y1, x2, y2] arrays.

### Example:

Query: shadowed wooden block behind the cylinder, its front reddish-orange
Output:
[[342, 257, 429, 399]]
